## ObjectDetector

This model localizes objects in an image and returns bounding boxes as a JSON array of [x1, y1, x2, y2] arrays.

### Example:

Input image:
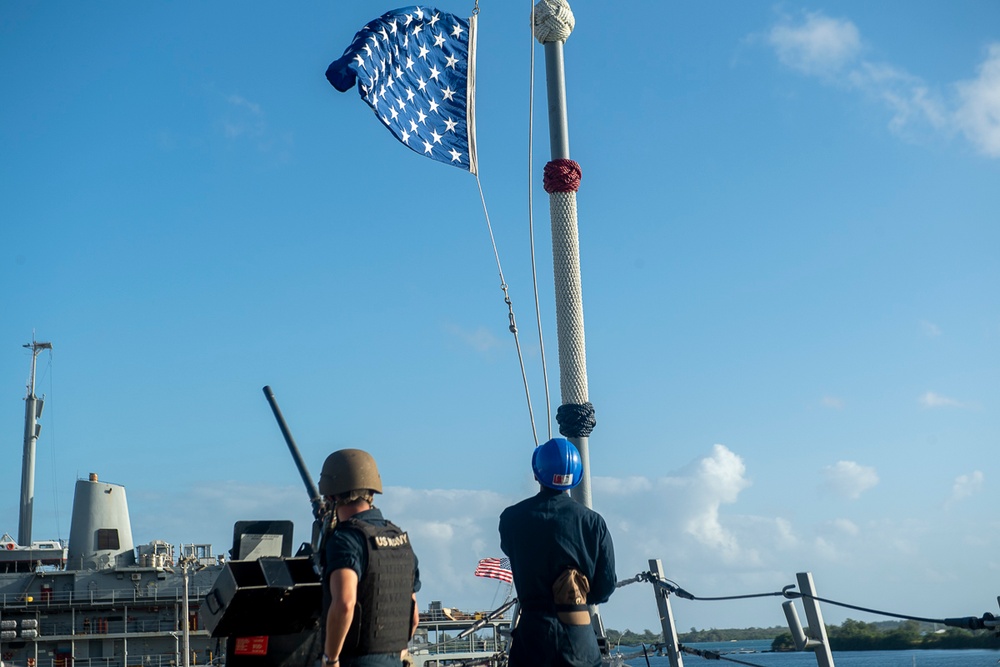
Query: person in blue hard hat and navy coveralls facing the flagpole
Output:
[[500, 438, 617, 667]]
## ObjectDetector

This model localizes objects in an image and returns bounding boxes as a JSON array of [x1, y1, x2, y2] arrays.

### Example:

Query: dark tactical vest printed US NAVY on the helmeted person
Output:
[[336, 518, 414, 656]]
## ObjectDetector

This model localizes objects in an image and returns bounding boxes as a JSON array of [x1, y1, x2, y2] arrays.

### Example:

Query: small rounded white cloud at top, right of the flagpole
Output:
[[767, 13, 861, 75]]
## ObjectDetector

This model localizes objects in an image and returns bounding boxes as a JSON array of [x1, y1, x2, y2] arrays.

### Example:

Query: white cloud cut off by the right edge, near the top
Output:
[[955, 43, 1000, 157]]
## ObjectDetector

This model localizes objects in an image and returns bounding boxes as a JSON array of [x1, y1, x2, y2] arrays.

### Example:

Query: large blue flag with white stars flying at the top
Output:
[[326, 7, 477, 174]]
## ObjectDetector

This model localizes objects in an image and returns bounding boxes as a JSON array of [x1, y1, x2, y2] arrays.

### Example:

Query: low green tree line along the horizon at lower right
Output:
[[607, 618, 1000, 651]]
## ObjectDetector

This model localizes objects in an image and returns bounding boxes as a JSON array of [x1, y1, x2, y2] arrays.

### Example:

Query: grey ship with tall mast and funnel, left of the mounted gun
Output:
[[0, 342, 224, 667]]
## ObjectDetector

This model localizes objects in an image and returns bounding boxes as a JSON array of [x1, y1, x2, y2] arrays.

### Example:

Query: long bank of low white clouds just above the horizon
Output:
[[119, 445, 1000, 631]]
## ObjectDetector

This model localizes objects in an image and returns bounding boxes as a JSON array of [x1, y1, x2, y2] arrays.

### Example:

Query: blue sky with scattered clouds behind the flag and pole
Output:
[[0, 0, 1000, 630]]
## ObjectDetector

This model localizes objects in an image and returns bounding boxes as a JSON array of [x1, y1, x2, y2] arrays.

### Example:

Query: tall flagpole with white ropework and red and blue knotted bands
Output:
[[534, 0, 597, 507]]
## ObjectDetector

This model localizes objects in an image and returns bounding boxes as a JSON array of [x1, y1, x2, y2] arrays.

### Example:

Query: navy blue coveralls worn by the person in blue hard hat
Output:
[[500, 488, 617, 667]]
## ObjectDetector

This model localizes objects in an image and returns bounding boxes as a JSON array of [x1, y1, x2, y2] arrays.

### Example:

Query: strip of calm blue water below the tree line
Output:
[[622, 640, 1000, 667]]
